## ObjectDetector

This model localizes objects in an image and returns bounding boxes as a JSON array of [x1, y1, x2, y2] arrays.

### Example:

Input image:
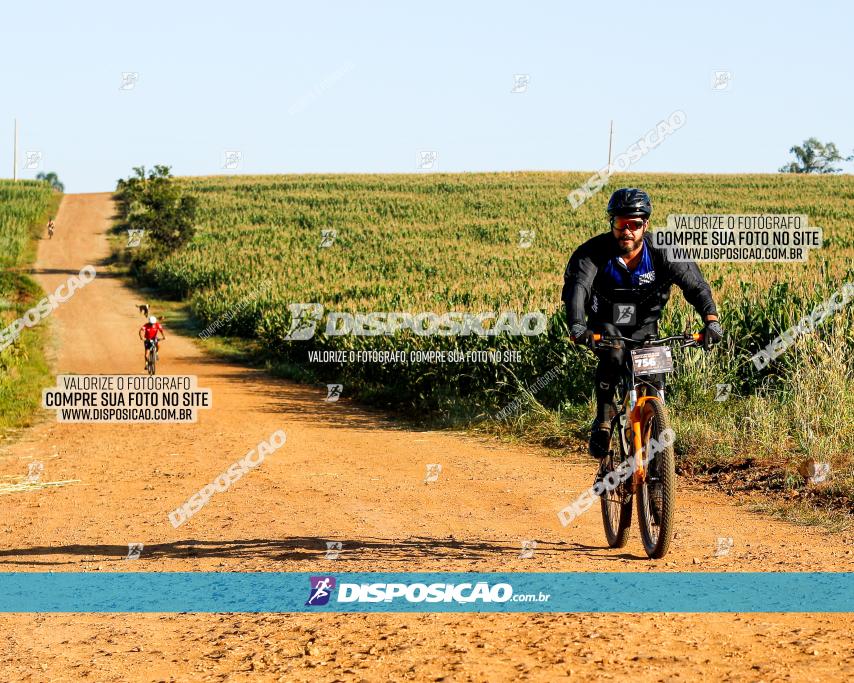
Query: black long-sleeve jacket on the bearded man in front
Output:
[[561, 232, 717, 327]]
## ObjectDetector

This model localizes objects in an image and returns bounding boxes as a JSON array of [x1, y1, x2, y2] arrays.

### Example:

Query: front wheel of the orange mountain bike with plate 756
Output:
[[637, 400, 676, 559]]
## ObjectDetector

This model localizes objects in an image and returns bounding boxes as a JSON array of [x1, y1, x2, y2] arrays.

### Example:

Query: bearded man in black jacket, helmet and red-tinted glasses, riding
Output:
[[561, 188, 723, 458]]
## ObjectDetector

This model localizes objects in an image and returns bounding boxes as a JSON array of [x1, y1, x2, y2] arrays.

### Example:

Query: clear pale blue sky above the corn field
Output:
[[0, 0, 854, 192]]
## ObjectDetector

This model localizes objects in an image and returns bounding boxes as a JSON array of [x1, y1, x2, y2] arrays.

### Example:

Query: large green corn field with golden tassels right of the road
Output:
[[125, 173, 854, 416]]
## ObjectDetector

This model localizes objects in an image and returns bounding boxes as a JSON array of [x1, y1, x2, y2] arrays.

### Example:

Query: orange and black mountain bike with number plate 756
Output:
[[591, 332, 703, 559]]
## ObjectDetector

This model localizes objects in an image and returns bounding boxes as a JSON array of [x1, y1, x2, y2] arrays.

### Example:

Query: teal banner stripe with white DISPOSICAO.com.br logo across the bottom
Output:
[[0, 572, 854, 612]]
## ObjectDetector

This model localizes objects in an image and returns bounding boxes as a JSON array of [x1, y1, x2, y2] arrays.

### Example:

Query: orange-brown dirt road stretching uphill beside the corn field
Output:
[[0, 194, 854, 681]]
